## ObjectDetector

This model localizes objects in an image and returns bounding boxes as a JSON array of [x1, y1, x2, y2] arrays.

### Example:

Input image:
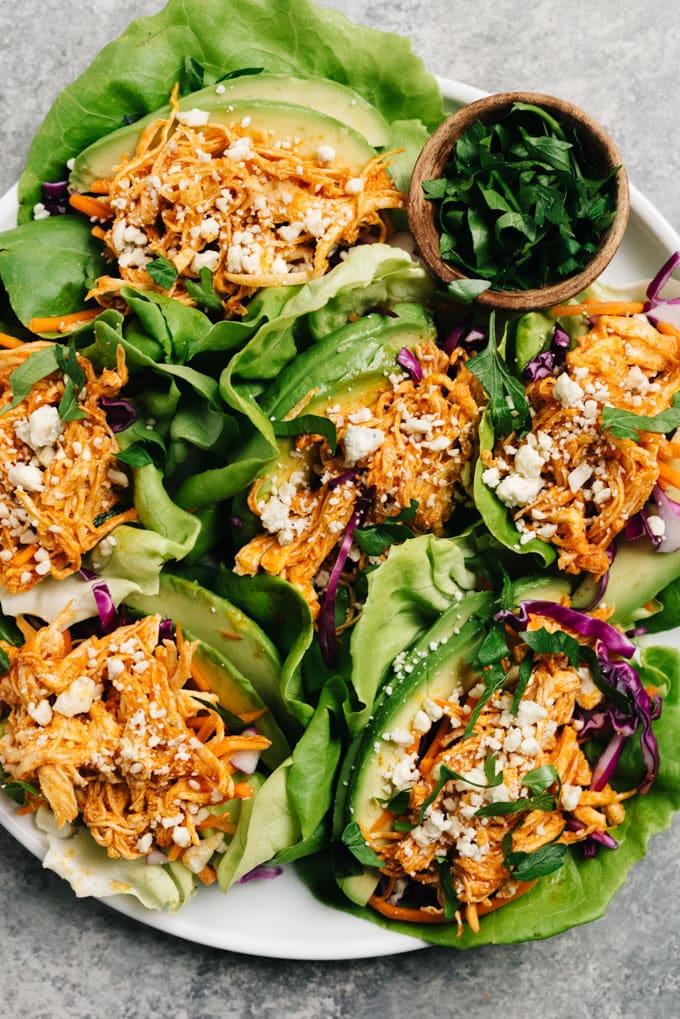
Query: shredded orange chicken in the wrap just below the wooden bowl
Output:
[[482, 315, 680, 577]]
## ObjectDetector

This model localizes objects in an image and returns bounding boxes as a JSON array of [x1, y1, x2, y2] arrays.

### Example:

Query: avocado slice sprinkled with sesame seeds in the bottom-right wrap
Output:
[[336, 592, 490, 906]]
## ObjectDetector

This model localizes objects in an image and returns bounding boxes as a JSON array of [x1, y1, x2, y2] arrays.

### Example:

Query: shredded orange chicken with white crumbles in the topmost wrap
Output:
[[83, 87, 405, 317]]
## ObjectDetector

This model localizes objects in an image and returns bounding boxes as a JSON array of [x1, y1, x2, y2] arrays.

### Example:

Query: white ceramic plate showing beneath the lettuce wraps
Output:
[[0, 78, 680, 960]]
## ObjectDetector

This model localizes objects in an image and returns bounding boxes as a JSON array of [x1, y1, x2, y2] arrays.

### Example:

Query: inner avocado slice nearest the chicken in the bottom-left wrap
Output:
[[190, 630, 291, 771]]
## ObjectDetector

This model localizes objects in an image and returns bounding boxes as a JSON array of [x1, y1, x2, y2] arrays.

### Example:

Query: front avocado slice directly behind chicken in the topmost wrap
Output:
[[69, 97, 375, 192]]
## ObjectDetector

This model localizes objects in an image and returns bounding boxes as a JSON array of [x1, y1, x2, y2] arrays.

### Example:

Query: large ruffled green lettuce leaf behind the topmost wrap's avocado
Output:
[[19, 0, 442, 220]]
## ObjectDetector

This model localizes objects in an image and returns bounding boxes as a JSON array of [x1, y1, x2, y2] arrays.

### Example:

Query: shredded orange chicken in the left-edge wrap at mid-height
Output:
[[0, 342, 137, 592]]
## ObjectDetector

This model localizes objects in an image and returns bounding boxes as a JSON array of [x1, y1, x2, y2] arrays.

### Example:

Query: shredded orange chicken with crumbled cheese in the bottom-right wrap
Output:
[[362, 619, 635, 930]]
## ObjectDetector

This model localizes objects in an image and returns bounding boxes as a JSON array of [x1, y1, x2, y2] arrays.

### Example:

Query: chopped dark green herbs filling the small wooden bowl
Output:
[[423, 103, 618, 290]]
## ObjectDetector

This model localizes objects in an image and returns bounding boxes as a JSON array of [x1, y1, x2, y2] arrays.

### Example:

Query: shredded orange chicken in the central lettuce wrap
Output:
[[236, 344, 482, 614]]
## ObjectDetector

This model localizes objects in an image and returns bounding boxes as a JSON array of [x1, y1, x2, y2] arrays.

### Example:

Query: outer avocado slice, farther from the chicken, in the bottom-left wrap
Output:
[[125, 574, 297, 736]]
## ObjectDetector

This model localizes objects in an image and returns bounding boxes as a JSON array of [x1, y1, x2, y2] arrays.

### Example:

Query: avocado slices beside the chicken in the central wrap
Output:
[[254, 313, 434, 495]]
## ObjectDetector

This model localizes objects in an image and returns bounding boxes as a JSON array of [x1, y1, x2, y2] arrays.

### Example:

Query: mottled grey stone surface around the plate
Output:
[[0, 0, 680, 1019]]
